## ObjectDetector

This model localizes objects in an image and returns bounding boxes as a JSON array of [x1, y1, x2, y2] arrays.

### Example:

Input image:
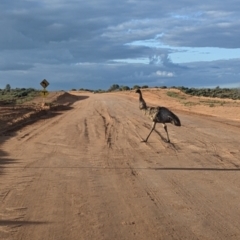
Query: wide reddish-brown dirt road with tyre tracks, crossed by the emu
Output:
[[0, 94, 240, 240]]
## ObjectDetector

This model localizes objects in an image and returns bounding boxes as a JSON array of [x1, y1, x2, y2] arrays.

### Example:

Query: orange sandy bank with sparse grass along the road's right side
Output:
[[115, 88, 240, 121]]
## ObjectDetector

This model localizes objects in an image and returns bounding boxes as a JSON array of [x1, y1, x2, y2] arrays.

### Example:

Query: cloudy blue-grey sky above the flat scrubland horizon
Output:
[[0, 0, 240, 90]]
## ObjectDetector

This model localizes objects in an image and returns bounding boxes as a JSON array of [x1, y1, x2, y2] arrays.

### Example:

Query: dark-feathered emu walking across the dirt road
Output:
[[136, 89, 181, 143]]
